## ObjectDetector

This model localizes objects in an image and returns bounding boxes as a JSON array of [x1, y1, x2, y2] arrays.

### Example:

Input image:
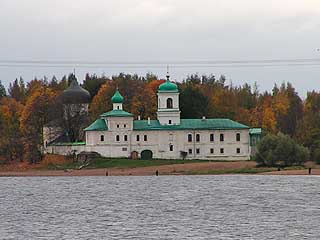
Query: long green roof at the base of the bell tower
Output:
[[133, 118, 249, 131]]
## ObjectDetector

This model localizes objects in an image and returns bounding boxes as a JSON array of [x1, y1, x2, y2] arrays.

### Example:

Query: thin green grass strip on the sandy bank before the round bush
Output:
[[185, 168, 277, 175]]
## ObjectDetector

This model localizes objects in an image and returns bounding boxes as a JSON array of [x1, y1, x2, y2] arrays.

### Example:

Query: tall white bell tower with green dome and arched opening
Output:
[[157, 73, 180, 125]]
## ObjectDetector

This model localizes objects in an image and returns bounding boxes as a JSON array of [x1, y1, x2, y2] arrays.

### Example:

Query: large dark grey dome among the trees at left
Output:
[[61, 80, 91, 104]]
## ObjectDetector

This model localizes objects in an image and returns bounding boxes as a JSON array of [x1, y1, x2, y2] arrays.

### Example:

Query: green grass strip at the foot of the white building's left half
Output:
[[45, 158, 208, 170]]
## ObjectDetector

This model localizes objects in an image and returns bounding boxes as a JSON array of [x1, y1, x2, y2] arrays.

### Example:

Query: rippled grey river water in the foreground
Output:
[[0, 175, 320, 240]]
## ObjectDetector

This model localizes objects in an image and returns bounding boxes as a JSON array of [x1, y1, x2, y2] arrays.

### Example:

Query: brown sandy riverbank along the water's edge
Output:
[[0, 160, 320, 177]]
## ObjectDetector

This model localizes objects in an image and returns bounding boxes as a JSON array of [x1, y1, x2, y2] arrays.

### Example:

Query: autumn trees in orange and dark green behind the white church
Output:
[[0, 73, 320, 163]]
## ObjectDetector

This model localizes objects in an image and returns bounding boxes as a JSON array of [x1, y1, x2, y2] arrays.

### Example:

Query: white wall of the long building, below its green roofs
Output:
[[86, 129, 250, 160]]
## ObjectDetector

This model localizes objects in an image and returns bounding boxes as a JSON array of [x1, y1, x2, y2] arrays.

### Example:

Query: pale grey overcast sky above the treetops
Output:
[[0, 0, 320, 96]]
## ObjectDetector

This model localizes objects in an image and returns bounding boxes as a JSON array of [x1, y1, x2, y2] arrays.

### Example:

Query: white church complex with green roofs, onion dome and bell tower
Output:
[[45, 76, 261, 160]]
